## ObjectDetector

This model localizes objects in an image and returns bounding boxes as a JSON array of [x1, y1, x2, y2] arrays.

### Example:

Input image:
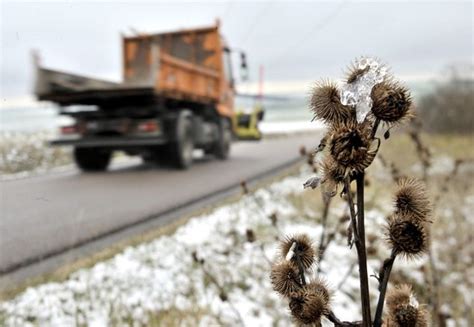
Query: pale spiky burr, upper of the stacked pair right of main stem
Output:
[[395, 178, 431, 222]]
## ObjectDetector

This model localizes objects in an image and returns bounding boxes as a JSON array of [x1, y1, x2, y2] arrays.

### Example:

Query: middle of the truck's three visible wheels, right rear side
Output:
[[169, 110, 194, 169]]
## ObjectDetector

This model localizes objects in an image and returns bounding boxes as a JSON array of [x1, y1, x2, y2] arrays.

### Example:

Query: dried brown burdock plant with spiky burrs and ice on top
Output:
[[270, 58, 431, 327]]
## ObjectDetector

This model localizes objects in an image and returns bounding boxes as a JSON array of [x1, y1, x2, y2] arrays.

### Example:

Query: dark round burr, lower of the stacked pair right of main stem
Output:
[[387, 214, 429, 258]]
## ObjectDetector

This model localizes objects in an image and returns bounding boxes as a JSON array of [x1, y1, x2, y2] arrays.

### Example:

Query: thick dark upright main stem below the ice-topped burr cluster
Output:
[[356, 172, 372, 327]]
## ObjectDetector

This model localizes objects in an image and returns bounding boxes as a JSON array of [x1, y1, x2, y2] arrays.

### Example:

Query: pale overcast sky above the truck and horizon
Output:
[[0, 0, 473, 98]]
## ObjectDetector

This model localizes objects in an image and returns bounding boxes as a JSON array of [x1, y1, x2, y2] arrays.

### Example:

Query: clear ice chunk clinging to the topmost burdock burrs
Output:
[[340, 57, 388, 123]]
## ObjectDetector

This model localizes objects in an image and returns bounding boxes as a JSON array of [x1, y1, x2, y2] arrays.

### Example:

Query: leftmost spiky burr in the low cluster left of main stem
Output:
[[270, 260, 300, 296]]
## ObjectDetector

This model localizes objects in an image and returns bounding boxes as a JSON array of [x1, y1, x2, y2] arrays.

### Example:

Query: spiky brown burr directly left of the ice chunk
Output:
[[310, 82, 355, 124]]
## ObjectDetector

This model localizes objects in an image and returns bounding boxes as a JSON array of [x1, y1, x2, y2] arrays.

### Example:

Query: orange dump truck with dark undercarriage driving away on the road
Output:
[[35, 23, 241, 171]]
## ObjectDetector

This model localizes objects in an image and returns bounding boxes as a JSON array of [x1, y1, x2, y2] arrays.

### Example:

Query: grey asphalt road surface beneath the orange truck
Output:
[[0, 134, 319, 275]]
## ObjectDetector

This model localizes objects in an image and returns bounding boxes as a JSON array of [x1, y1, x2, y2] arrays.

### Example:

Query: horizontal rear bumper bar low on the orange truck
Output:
[[49, 136, 167, 148]]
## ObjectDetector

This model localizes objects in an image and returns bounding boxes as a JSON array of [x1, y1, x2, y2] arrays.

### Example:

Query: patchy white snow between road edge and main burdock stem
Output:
[[0, 171, 386, 326]]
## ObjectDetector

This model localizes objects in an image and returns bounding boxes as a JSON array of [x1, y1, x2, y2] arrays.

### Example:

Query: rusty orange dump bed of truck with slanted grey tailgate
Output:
[[35, 26, 231, 110]]
